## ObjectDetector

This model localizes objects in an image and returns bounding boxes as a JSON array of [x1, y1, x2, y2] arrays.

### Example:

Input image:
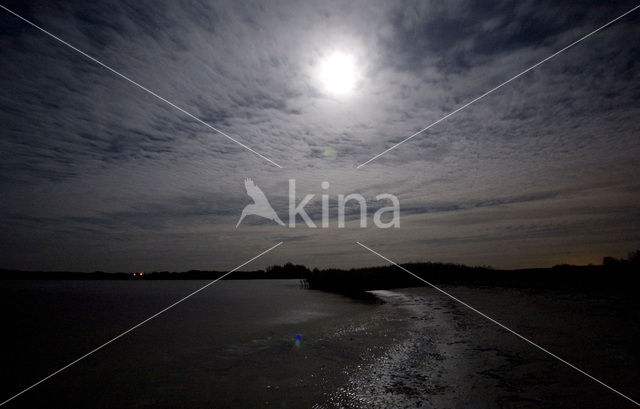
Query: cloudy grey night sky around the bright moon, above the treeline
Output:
[[0, 0, 640, 271]]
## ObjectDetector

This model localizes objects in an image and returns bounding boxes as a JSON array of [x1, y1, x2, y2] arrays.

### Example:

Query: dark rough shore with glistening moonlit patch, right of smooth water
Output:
[[318, 286, 640, 409]]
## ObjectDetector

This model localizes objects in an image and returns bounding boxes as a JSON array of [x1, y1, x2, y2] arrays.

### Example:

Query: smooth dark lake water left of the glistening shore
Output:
[[0, 280, 384, 408]]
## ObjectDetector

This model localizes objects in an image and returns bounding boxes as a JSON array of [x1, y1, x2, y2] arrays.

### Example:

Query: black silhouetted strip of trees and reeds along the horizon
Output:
[[0, 250, 640, 296]]
